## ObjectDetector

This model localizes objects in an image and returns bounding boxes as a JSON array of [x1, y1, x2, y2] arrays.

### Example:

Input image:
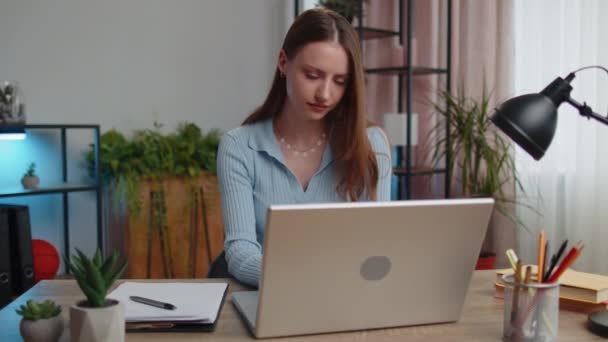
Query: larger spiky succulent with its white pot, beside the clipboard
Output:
[[69, 249, 127, 342]]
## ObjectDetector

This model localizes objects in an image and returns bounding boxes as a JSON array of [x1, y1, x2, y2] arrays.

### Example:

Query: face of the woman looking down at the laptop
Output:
[[279, 41, 348, 120]]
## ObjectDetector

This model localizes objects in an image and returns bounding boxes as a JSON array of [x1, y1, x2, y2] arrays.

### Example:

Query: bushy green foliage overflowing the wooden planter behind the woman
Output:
[[86, 123, 221, 213]]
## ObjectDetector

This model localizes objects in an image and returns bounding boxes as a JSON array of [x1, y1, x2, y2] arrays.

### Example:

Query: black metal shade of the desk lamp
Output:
[[491, 93, 557, 160]]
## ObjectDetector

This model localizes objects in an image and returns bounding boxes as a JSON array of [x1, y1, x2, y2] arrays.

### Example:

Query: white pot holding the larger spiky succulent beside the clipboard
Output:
[[70, 299, 125, 342]]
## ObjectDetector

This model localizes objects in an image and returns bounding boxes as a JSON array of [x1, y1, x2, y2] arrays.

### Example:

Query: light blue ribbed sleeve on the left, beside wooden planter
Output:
[[217, 134, 262, 287]]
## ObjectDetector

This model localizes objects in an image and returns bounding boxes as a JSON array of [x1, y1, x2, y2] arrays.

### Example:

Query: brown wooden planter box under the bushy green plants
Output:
[[104, 173, 224, 279]]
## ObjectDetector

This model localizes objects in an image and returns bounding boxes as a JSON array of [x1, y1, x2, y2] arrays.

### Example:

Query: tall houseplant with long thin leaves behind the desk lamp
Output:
[[431, 84, 525, 268]]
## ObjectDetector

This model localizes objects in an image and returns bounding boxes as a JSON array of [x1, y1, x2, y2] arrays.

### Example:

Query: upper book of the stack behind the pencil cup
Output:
[[496, 265, 608, 303]]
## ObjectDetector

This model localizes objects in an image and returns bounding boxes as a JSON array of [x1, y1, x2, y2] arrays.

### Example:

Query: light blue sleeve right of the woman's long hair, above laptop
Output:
[[368, 126, 393, 202]]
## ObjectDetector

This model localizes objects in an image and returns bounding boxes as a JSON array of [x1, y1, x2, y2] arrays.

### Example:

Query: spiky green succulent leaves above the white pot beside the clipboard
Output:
[[68, 249, 127, 308]]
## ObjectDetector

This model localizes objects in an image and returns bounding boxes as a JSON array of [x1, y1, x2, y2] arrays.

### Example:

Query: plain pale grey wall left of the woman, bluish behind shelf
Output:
[[0, 0, 293, 272]]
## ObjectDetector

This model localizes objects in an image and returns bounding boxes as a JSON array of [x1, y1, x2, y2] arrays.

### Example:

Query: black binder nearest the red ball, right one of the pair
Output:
[[0, 204, 35, 296]]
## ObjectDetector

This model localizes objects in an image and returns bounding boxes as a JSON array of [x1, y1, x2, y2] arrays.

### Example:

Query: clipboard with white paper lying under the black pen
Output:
[[108, 282, 228, 331]]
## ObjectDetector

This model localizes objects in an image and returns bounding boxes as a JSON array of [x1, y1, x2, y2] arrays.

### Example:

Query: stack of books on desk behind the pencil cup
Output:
[[494, 266, 608, 313]]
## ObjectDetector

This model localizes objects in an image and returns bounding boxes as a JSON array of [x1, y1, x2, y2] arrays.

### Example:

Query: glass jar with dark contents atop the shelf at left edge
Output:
[[0, 81, 25, 140]]
